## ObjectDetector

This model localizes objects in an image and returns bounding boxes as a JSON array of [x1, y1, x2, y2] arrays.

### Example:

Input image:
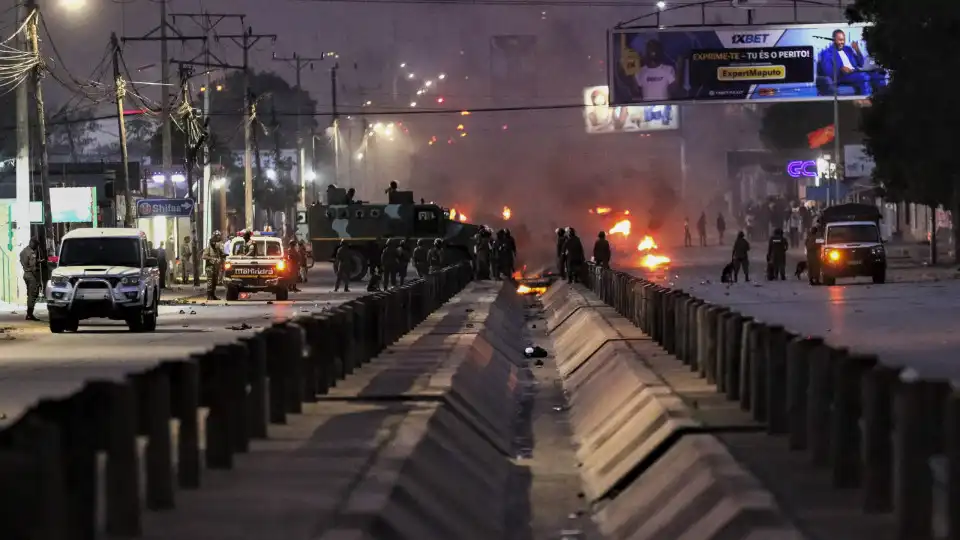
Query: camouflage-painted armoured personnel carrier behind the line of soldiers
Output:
[[307, 187, 480, 281]]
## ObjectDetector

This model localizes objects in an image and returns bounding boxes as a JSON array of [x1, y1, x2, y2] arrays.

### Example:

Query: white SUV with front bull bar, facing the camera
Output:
[[45, 228, 160, 334]]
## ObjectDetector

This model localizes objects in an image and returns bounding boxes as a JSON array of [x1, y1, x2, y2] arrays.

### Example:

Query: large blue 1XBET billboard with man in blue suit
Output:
[[609, 23, 890, 105]]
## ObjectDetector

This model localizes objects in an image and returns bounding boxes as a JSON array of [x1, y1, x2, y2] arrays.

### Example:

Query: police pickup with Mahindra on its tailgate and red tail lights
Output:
[[223, 232, 289, 300]]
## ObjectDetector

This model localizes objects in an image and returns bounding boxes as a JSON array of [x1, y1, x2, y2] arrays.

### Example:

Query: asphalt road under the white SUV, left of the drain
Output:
[[0, 263, 366, 425]]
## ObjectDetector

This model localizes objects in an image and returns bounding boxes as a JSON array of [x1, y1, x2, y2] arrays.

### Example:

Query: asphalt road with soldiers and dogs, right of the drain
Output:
[[624, 247, 960, 379]]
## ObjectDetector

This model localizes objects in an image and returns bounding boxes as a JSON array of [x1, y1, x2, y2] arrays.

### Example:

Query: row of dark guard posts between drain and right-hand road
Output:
[[587, 266, 960, 540]]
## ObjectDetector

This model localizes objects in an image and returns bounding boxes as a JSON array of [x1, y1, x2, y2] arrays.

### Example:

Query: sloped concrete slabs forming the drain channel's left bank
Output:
[[320, 282, 523, 540]]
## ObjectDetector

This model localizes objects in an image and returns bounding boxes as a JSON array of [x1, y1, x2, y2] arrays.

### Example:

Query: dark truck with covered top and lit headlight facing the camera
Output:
[[817, 204, 887, 286]]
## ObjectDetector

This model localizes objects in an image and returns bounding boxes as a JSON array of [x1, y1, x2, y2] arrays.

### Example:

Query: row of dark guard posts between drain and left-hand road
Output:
[[0, 265, 471, 540]]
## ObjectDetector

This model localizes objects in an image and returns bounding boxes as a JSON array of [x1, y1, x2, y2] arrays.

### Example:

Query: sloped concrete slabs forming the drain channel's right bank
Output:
[[541, 283, 802, 540]]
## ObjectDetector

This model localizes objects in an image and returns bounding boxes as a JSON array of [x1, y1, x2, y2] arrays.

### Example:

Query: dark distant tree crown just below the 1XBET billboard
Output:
[[760, 101, 861, 151]]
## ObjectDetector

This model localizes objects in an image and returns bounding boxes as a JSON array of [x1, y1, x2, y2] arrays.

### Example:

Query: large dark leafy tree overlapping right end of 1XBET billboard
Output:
[[847, 0, 960, 263]]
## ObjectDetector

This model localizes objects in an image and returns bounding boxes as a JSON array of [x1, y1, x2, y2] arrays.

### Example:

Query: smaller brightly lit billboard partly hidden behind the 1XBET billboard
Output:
[[583, 86, 680, 134]]
